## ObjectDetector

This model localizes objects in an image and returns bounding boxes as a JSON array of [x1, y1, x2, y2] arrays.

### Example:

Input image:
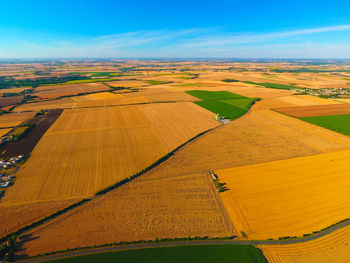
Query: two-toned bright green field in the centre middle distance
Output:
[[186, 90, 257, 120]]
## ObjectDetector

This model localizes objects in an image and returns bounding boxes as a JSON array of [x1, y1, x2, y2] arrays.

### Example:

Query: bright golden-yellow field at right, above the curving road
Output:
[[217, 150, 350, 239]]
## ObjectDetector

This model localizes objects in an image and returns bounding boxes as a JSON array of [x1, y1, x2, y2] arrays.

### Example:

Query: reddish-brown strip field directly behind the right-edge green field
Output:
[[274, 104, 350, 118]]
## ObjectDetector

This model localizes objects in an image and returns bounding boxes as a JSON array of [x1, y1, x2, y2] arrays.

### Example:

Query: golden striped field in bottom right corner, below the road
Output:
[[259, 227, 350, 263]]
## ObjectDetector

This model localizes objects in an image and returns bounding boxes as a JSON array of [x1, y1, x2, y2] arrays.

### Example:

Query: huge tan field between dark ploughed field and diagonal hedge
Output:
[[1, 102, 219, 204]]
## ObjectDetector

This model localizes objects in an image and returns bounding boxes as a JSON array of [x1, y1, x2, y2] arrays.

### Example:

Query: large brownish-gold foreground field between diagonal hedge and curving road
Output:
[[19, 174, 234, 255]]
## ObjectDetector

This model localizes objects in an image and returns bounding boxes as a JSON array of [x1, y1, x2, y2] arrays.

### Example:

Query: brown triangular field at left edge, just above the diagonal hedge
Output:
[[0, 200, 77, 239]]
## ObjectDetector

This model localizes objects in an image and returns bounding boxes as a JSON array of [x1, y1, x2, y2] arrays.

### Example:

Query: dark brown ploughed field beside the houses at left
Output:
[[0, 110, 62, 158]]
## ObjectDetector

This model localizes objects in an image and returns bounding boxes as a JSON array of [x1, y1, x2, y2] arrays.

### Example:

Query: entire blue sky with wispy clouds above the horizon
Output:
[[0, 0, 350, 58]]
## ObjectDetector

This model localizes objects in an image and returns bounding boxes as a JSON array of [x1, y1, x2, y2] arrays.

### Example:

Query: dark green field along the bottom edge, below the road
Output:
[[45, 245, 267, 263]]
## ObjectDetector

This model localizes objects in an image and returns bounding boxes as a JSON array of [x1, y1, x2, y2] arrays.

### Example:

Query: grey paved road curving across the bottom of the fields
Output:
[[17, 220, 350, 263]]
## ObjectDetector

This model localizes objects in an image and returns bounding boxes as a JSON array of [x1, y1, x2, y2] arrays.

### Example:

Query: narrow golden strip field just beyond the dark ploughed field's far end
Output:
[[14, 98, 76, 112]]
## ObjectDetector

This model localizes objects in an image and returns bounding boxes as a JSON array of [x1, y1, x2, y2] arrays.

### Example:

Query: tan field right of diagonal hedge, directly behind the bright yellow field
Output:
[[143, 110, 350, 182]]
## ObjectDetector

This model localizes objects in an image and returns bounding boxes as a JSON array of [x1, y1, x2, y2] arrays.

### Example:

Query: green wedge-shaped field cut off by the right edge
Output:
[[300, 114, 350, 136]]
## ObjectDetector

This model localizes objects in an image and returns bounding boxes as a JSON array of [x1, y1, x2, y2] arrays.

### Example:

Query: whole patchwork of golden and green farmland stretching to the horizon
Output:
[[0, 59, 350, 262]]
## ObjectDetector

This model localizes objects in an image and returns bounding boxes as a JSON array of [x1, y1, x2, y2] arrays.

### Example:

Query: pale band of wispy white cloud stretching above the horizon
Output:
[[0, 25, 350, 58]]
